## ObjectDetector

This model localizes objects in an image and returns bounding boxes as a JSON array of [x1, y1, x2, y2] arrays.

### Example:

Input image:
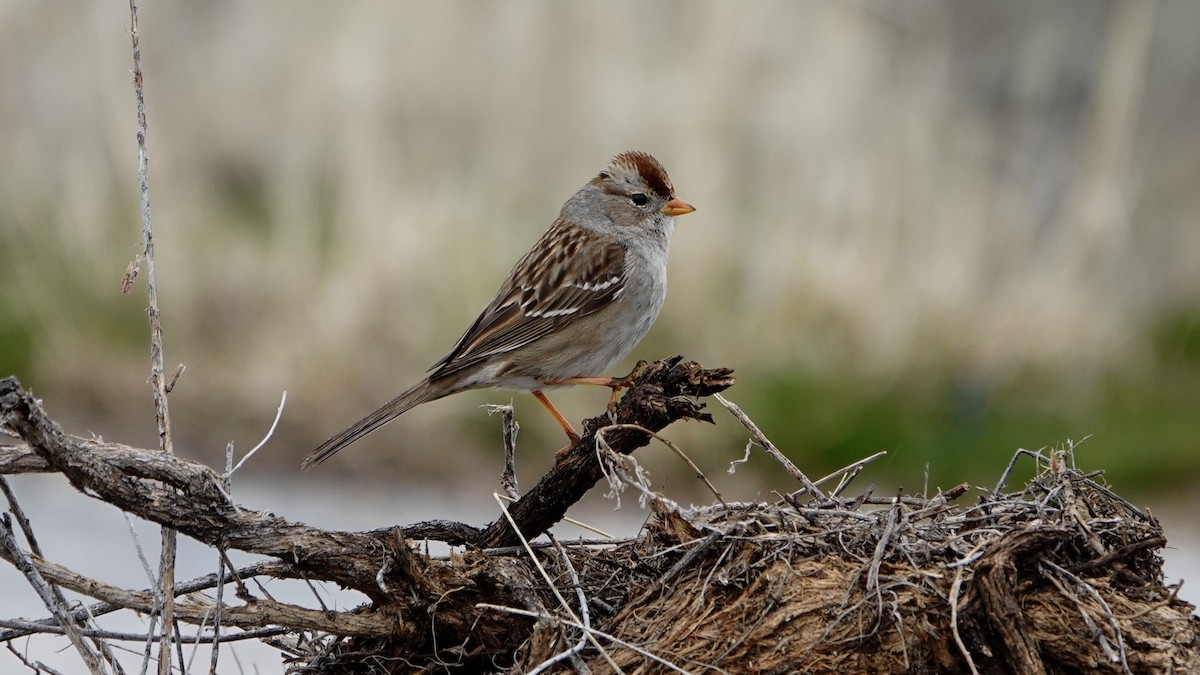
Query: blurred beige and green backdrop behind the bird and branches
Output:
[[0, 0, 1200, 667]]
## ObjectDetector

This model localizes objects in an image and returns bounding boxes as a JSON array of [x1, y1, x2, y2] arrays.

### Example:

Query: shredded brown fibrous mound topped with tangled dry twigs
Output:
[[297, 449, 1200, 674]]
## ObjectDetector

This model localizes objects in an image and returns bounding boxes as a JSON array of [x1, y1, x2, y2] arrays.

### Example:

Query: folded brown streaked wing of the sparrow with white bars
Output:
[[430, 221, 625, 380]]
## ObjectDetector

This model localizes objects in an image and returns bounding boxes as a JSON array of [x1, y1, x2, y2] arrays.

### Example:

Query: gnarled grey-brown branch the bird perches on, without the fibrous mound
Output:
[[0, 357, 733, 670]]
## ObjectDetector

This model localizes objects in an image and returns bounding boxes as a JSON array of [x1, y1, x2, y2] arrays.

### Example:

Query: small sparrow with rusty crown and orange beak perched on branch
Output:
[[304, 151, 696, 468]]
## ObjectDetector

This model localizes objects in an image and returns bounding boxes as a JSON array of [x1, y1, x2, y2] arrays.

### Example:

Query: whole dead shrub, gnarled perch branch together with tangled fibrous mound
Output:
[[0, 367, 1200, 674]]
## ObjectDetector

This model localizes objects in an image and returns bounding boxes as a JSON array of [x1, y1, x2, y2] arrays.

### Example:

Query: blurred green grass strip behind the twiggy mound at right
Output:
[[731, 309, 1200, 492]]
